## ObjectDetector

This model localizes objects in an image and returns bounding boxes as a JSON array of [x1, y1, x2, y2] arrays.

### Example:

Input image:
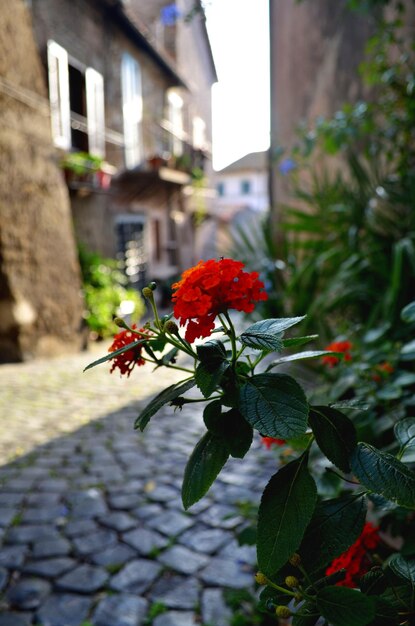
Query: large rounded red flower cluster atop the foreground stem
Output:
[[172, 259, 268, 343]]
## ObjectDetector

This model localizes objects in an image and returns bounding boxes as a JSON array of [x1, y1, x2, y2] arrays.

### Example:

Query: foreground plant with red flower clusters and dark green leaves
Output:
[[86, 259, 415, 626]]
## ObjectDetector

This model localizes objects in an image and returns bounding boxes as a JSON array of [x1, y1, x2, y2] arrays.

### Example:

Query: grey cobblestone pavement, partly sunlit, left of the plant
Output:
[[0, 348, 274, 626]]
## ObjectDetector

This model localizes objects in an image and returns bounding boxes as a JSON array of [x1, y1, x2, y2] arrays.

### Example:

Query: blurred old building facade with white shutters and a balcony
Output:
[[30, 0, 216, 288]]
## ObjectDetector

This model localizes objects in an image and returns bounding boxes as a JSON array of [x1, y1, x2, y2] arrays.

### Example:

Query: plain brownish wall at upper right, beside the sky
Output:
[[270, 0, 415, 217]]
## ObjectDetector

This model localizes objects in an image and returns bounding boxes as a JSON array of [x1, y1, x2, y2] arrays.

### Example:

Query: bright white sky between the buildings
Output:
[[206, 0, 269, 170]]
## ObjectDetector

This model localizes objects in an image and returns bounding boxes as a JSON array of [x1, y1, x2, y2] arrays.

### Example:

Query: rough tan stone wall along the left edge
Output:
[[0, 0, 82, 362]]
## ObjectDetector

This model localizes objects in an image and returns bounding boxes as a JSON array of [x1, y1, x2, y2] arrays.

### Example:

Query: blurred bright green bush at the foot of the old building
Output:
[[79, 246, 145, 338]]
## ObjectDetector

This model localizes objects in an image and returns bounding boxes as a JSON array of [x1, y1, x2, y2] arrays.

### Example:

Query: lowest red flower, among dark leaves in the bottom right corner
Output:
[[326, 522, 380, 587]]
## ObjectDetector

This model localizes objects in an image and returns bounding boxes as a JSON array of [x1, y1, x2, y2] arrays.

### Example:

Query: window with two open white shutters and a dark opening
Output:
[[48, 41, 105, 156]]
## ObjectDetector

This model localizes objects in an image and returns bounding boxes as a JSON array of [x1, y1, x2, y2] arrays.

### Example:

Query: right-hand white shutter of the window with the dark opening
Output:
[[85, 67, 105, 157]]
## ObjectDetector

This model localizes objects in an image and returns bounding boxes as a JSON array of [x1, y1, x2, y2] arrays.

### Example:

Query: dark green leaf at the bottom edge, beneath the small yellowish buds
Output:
[[317, 587, 375, 626]]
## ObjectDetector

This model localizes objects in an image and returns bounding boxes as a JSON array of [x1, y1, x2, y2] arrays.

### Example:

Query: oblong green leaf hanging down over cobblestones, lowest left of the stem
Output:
[[182, 432, 229, 509]]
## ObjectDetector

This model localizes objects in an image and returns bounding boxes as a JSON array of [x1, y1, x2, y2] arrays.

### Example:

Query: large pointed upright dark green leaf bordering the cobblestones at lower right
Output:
[[257, 454, 317, 578]]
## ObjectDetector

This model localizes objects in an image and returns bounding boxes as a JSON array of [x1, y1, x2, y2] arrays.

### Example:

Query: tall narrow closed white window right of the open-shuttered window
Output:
[[121, 53, 143, 168]]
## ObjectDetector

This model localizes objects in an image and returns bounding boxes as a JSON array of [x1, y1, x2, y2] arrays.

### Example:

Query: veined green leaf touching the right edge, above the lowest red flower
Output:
[[350, 443, 415, 509]]
